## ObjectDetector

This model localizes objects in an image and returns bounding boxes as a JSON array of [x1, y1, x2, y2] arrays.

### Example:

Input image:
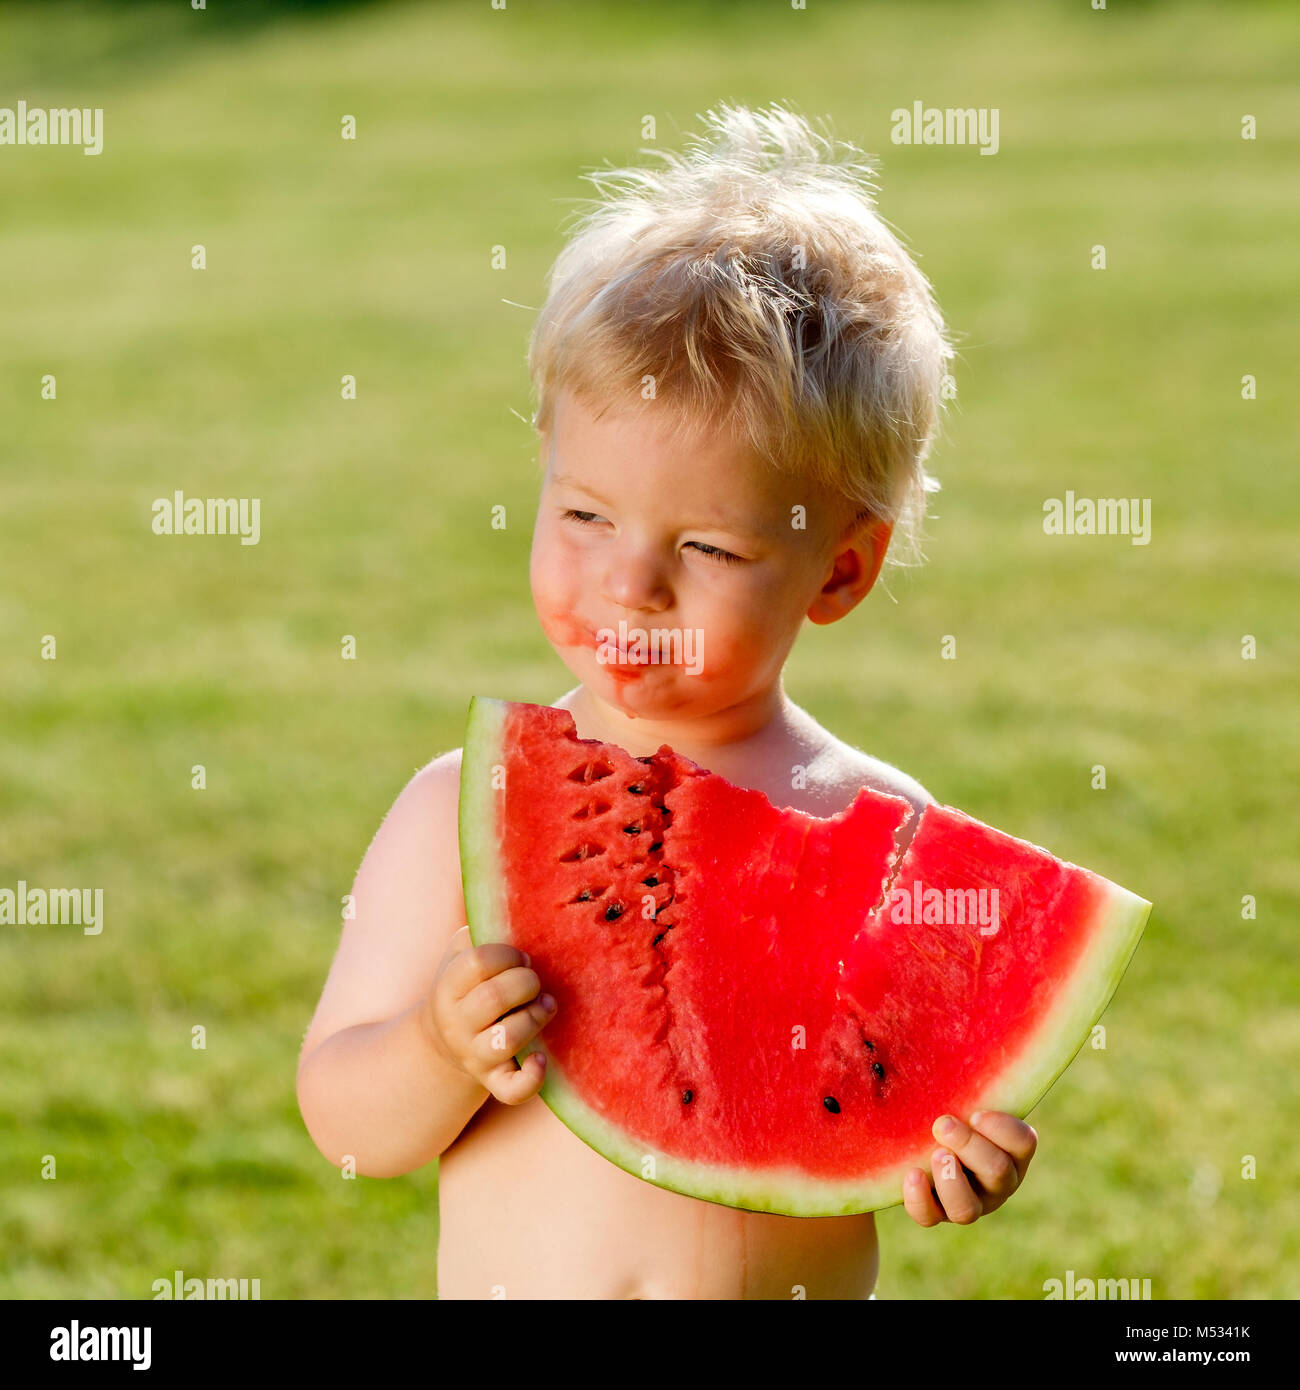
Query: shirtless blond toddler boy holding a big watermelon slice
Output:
[[298, 106, 1037, 1298]]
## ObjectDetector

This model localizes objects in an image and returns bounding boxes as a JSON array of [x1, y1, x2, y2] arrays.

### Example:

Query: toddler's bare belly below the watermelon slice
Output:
[[438, 1098, 877, 1298]]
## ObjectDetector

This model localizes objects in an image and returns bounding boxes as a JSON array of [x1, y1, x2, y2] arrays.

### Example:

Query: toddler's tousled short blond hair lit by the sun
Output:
[[528, 103, 952, 563]]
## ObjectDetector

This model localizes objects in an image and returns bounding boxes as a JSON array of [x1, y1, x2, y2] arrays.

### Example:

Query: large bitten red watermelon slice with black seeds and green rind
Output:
[[460, 699, 1151, 1216]]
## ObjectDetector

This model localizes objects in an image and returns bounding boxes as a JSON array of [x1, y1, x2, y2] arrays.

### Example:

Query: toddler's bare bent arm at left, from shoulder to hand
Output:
[[298, 753, 549, 1177]]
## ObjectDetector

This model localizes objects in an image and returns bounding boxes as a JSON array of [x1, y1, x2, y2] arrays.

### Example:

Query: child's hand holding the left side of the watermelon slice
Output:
[[425, 927, 555, 1105]]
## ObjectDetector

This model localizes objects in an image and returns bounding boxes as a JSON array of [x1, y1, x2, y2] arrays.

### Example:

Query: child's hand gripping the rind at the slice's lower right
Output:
[[902, 1111, 1039, 1226]]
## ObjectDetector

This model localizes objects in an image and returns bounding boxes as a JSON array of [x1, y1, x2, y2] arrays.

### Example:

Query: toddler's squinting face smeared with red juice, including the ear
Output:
[[530, 392, 890, 720]]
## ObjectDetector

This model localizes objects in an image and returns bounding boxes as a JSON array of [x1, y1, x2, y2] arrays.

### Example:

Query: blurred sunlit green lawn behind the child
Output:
[[0, 0, 1300, 1298]]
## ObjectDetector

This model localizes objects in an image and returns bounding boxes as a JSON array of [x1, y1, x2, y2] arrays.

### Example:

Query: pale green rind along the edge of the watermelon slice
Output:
[[459, 696, 1151, 1216]]
